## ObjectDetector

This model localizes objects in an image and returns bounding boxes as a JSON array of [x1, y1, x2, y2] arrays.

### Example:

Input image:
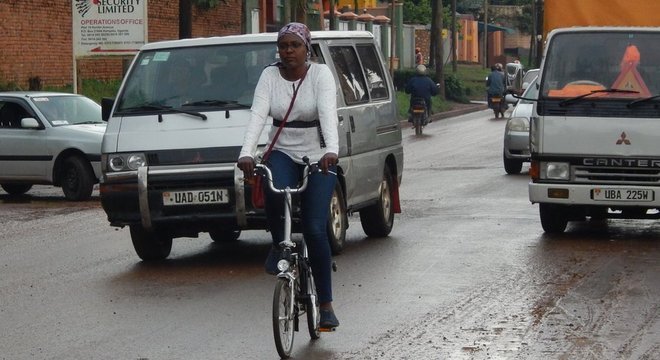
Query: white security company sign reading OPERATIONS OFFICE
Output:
[[71, 0, 147, 57]]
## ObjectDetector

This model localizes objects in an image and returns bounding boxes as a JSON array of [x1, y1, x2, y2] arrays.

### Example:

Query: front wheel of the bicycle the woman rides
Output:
[[273, 279, 295, 359]]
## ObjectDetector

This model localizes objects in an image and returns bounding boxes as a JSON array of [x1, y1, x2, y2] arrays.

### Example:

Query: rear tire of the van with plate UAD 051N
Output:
[[360, 164, 394, 237]]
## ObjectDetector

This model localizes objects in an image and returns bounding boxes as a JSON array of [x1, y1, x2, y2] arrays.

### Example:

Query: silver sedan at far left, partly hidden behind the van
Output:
[[0, 91, 106, 201]]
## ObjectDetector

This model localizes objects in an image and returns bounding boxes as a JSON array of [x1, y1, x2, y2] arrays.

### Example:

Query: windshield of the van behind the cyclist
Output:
[[116, 43, 277, 114]]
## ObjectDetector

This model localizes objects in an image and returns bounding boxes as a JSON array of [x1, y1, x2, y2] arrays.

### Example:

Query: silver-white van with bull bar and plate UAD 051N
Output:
[[100, 31, 403, 261]]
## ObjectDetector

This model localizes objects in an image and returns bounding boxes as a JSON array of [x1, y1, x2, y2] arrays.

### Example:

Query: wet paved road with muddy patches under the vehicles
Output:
[[0, 111, 660, 360]]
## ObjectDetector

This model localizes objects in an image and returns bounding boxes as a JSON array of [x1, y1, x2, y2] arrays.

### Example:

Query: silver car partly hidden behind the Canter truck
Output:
[[502, 77, 539, 174]]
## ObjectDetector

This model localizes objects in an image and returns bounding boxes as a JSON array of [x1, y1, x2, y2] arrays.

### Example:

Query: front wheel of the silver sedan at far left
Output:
[[61, 156, 94, 201]]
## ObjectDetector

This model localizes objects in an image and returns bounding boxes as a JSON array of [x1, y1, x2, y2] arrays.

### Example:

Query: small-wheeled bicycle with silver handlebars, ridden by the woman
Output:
[[255, 157, 334, 359]]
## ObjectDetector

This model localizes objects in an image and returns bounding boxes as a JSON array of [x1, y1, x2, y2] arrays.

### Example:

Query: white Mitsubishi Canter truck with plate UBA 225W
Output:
[[529, 26, 660, 233]]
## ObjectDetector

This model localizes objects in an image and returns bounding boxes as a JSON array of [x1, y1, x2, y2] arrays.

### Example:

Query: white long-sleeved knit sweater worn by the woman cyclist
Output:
[[239, 64, 339, 163]]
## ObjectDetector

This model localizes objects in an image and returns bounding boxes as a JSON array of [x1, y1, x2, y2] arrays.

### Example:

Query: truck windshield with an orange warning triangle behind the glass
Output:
[[541, 30, 660, 102]]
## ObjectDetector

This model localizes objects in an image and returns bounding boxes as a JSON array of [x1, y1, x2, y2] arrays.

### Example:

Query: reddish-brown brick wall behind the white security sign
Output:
[[0, 0, 243, 89]]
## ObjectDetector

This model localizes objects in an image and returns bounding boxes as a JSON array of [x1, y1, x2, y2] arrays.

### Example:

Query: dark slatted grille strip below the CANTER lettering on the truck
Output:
[[572, 166, 660, 185]]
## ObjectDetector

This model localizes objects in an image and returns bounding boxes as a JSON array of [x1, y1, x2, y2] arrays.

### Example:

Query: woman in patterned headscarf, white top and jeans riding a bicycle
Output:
[[238, 23, 339, 328]]
